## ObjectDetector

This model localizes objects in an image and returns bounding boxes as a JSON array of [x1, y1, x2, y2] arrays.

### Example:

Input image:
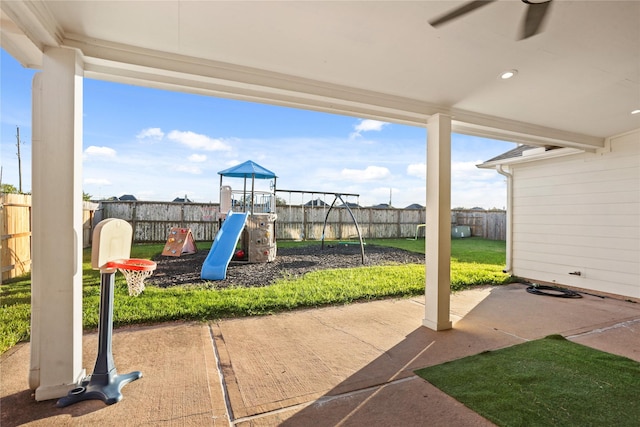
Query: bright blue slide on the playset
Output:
[[200, 212, 249, 280]]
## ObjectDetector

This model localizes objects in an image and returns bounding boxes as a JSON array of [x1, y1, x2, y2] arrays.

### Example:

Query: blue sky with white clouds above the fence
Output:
[[0, 50, 514, 208]]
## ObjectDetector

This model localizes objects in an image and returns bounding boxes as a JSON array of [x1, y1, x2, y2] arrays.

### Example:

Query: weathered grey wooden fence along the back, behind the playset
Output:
[[95, 201, 506, 242]]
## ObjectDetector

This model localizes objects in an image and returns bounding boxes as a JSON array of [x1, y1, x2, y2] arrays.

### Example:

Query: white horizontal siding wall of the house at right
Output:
[[512, 130, 640, 298]]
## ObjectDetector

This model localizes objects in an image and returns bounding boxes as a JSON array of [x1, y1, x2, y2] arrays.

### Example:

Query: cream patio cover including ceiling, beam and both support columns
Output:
[[0, 0, 640, 406]]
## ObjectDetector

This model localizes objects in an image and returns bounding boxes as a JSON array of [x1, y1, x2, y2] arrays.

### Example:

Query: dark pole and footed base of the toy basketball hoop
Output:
[[56, 272, 142, 408]]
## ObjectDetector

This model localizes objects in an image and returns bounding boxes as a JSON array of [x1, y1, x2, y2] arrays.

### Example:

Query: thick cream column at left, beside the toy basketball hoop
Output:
[[29, 48, 85, 400]]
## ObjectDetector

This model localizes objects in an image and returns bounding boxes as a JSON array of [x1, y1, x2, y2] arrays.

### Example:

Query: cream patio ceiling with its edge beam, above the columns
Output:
[[0, 0, 640, 149]]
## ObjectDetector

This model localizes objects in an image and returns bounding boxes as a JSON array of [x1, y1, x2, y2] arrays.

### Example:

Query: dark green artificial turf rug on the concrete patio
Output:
[[416, 335, 640, 427]]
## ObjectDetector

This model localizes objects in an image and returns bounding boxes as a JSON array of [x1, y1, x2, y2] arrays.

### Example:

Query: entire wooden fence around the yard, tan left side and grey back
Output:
[[0, 199, 507, 283]]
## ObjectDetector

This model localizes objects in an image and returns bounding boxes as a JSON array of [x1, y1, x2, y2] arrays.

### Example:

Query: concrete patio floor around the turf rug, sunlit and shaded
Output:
[[0, 284, 640, 427]]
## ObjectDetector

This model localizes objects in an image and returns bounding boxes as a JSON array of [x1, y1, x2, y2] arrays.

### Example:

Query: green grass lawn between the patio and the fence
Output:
[[0, 238, 511, 353]]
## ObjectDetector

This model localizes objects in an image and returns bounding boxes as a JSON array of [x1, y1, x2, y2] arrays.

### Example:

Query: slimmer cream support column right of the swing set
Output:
[[422, 114, 451, 331]]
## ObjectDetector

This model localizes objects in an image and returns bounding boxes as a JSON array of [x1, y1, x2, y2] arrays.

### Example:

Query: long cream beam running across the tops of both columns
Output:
[[75, 36, 604, 151]]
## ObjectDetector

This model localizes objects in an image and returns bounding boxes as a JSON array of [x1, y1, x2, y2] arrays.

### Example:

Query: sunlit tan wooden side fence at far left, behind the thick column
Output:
[[0, 193, 98, 283]]
